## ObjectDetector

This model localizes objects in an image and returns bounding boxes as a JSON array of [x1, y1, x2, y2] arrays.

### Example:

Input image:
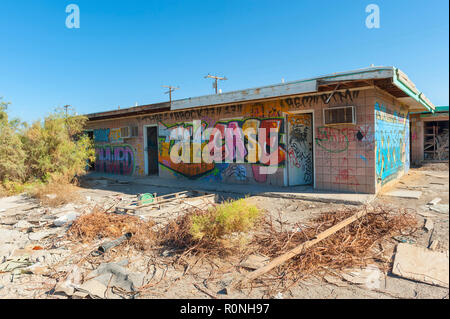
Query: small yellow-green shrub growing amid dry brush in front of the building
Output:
[[191, 199, 260, 241]]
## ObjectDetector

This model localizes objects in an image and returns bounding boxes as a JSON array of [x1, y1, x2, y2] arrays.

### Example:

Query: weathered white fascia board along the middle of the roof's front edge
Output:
[[170, 80, 317, 110]]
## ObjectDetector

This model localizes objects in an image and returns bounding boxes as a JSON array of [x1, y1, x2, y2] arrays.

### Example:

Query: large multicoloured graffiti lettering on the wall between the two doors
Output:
[[158, 118, 286, 182]]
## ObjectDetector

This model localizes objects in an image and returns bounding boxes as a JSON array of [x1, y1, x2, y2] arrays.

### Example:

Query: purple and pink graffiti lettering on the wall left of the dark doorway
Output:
[[95, 144, 134, 175]]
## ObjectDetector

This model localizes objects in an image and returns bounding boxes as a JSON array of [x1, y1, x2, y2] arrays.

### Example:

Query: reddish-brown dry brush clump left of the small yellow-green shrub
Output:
[[68, 208, 156, 250]]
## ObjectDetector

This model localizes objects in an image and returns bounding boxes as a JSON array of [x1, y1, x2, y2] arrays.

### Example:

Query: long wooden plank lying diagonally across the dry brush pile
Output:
[[227, 209, 368, 290]]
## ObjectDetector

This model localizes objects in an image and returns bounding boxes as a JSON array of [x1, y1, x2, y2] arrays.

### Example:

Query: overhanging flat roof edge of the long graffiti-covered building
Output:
[[86, 66, 435, 120]]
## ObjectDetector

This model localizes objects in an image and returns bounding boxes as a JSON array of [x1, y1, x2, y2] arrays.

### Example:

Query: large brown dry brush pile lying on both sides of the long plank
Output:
[[253, 207, 417, 280]]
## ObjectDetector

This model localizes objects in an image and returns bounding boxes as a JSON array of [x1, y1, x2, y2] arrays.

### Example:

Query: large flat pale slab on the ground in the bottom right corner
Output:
[[392, 244, 449, 288]]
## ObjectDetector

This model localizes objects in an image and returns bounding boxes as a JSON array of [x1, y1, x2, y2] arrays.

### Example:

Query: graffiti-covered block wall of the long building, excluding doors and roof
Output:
[[84, 89, 409, 193]]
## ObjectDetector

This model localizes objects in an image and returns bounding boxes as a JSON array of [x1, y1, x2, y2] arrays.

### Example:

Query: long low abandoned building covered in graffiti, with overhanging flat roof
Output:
[[86, 67, 436, 194]]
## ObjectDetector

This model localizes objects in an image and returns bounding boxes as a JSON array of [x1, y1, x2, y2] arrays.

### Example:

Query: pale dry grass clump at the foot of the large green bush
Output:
[[29, 179, 81, 207]]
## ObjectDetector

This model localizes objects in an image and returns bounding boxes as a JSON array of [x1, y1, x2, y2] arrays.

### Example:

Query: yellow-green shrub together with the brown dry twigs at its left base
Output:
[[158, 199, 261, 253]]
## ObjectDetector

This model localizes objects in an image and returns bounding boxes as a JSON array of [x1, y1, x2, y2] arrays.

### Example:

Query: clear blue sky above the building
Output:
[[0, 0, 449, 121]]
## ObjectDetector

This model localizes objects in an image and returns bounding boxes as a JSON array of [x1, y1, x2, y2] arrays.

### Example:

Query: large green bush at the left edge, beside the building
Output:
[[0, 98, 95, 195]]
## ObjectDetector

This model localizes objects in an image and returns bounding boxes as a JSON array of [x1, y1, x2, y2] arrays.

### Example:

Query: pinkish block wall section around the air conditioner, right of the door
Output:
[[314, 89, 375, 193]]
